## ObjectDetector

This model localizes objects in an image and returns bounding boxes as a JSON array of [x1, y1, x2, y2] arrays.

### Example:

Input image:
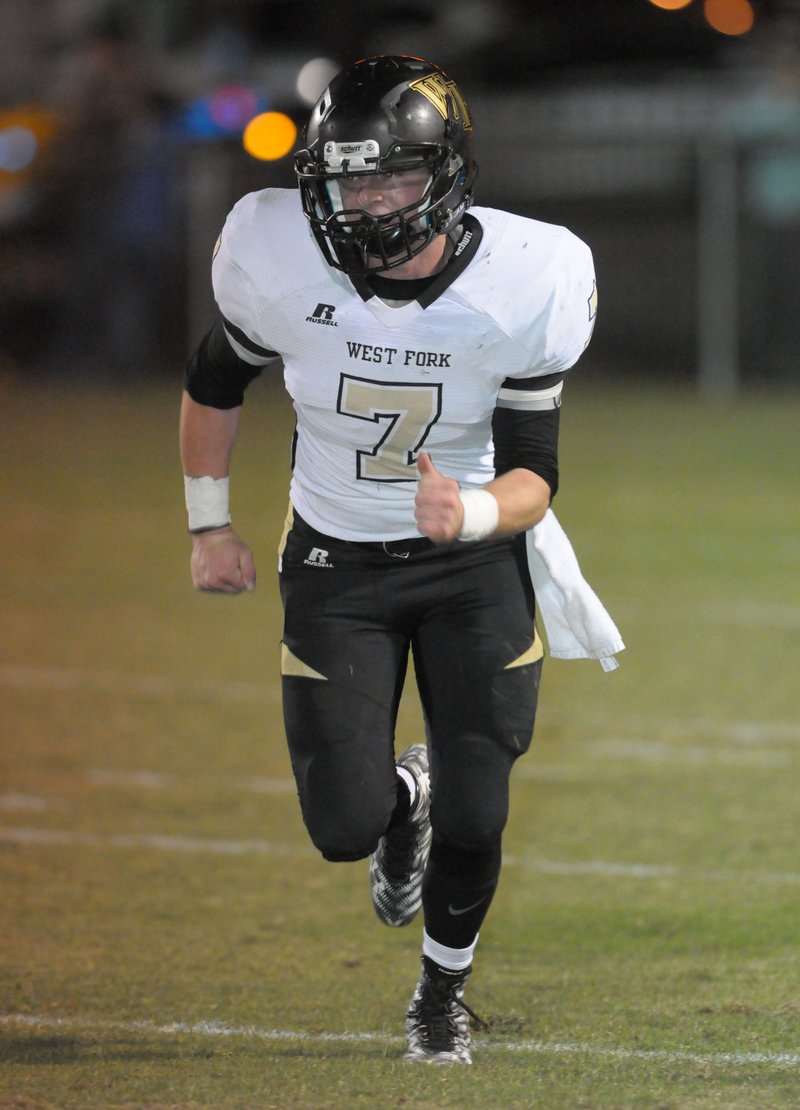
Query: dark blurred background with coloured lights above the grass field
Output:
[[0, 0, 800, 395]]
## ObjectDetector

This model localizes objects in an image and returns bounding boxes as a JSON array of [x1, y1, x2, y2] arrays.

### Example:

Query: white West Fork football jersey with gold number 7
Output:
[[213, 189, 596, 541]]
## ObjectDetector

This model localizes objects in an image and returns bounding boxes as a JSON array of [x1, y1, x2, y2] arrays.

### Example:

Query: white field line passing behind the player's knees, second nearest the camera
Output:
[[0, 826, 800, 885]]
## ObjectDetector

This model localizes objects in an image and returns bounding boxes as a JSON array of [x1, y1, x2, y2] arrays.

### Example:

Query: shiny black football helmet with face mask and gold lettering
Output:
[[294, 56, 477, 275]]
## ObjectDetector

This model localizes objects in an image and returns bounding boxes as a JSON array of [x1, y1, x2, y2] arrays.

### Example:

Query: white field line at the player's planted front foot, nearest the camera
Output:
[[0, 1013, 800, 1068]]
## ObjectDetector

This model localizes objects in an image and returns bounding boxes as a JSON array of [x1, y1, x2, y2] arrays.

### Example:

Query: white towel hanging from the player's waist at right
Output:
[[526, 508, 625, 670]]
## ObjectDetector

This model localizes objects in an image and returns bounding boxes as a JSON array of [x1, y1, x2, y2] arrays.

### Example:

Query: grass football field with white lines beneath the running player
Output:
[[0, 373, 800, 1110]]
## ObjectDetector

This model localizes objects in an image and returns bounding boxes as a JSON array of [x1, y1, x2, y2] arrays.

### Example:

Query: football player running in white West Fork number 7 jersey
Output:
[[181, 57, 596, 1063]]
